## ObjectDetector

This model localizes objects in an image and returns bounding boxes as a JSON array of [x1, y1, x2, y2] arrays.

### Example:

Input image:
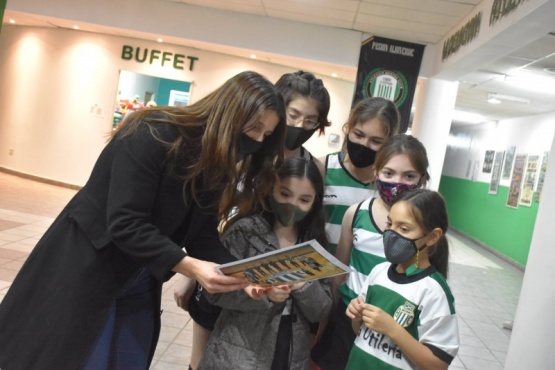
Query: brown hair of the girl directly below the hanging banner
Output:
[[343, 97, 401, 145]]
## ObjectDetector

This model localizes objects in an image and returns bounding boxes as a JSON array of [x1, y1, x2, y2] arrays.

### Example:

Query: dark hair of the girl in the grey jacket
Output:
[[264, 157, 328, 249]]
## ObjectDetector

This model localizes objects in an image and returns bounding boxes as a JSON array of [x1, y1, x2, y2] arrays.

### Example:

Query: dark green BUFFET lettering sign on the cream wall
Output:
[[121, 45, 198, 71]]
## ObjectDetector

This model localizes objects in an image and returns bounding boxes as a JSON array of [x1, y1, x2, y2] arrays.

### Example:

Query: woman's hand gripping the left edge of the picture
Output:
[[173, 256, 248, 293]]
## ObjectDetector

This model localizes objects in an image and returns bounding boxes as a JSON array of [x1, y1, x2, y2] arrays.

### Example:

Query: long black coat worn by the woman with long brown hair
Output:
[[0, 123, 230, 370]]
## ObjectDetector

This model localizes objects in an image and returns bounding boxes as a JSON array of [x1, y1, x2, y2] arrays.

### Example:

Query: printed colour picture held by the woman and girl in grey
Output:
[[217, 239, 351, 286]]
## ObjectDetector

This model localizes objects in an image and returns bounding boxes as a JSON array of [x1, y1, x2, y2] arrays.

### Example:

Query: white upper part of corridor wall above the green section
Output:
[[442, 113, 555, 186]]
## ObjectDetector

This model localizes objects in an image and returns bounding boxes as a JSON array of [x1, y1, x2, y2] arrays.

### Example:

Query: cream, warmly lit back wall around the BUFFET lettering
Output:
[[0, 26, 354, 185]]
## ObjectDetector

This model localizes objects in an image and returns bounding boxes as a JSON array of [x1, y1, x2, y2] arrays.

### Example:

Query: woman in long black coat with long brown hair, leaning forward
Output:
[[0, 72, 285, 370]]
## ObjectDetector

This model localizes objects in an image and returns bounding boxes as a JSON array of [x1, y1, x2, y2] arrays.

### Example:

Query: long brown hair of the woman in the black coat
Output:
[[115, 71, 286, 218]]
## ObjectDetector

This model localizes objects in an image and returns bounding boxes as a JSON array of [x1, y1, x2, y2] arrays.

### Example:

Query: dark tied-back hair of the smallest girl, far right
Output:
[[396, 189, 449, 278]]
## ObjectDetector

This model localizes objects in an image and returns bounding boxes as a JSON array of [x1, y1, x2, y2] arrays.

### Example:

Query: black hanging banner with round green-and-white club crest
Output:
[[353, 36, 425, 133]]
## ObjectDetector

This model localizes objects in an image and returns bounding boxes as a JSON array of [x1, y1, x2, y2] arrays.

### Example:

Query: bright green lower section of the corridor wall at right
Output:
[[439, 176, 538, 266]]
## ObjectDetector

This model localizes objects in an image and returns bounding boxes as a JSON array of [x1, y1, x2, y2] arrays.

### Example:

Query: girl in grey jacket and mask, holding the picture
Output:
[[198, 158, 332, 370]]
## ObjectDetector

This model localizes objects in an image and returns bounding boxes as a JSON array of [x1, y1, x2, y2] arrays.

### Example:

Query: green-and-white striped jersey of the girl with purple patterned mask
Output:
[[339, 198, 387, 306]]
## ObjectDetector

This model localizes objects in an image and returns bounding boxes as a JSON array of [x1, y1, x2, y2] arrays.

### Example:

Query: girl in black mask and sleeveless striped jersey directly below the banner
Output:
[[318, 98, 400, 252]]
